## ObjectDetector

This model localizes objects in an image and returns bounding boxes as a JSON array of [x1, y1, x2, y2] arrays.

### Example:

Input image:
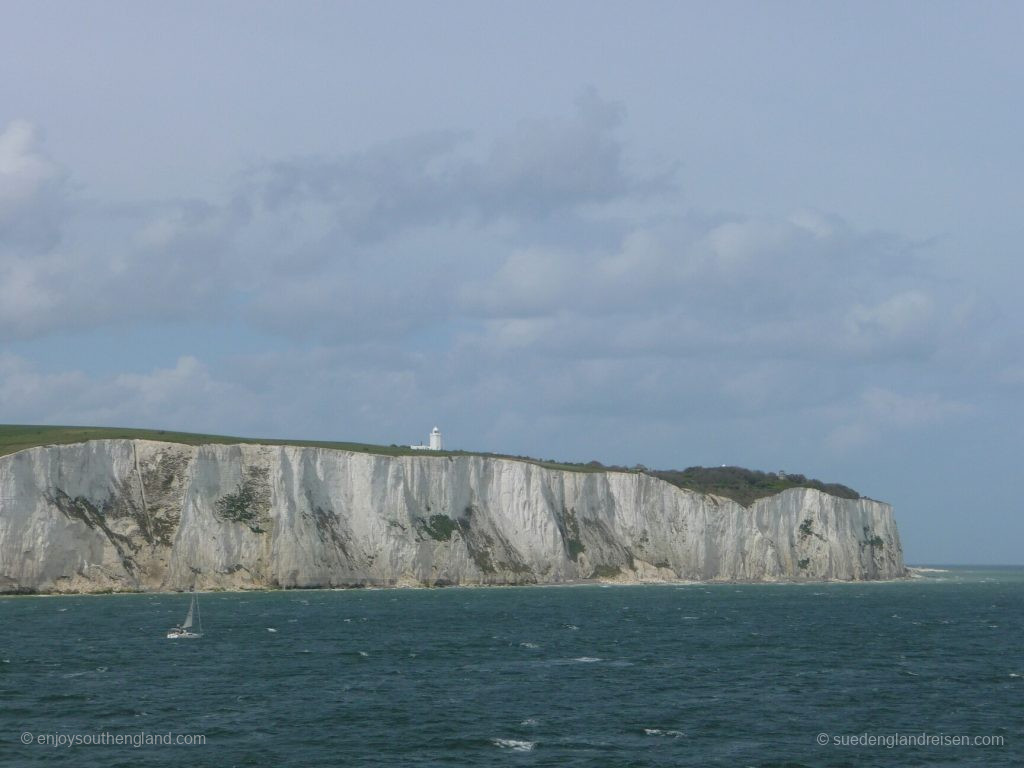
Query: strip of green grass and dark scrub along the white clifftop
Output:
[[0, 424, 860, 507]]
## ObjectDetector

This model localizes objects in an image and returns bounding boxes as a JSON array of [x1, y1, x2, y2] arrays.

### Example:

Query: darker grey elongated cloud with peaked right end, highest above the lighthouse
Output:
[[245, 91, 671, 241]]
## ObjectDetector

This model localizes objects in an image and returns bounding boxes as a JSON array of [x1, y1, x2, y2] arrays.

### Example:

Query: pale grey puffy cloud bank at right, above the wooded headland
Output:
[[460, 212, 971, 368]]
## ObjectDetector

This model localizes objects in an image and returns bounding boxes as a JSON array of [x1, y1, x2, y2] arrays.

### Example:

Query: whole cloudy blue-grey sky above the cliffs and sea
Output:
[[0, 0, 1024, 564]]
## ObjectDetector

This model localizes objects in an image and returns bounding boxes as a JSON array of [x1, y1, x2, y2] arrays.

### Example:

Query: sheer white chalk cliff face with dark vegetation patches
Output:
[[0, 440, 904, 592]]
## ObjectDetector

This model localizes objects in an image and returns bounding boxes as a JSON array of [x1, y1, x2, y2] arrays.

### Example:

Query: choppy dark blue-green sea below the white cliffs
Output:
[[0, 568, 1024, 768]]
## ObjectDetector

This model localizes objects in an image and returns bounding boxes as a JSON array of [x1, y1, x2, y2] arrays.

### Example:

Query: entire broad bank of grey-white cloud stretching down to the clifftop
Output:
[[0, 93, 1013, 468]]
